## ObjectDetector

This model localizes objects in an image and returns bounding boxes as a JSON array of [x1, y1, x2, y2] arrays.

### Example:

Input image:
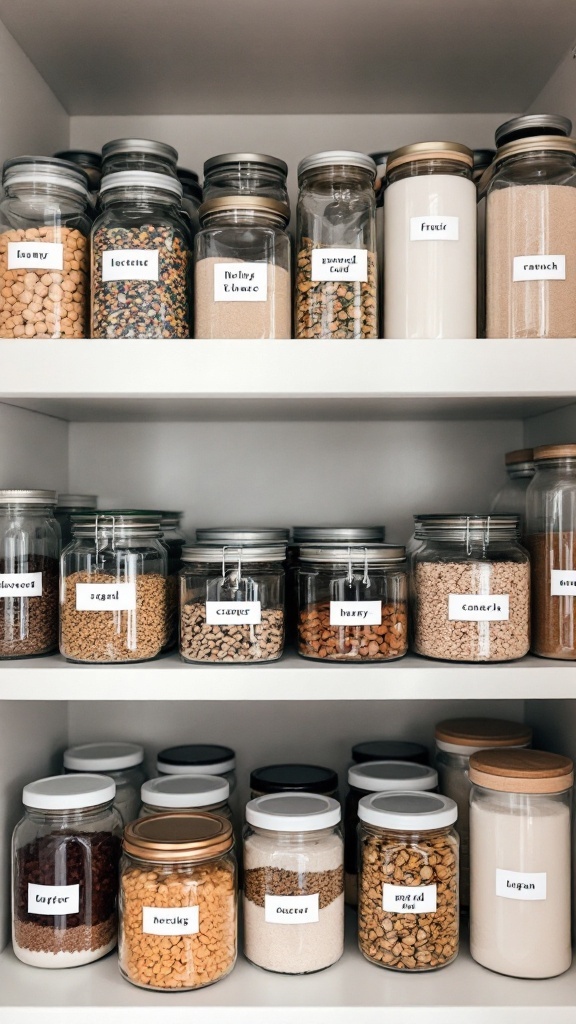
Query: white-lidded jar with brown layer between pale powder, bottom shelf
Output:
[[244, 793, 344, 974]]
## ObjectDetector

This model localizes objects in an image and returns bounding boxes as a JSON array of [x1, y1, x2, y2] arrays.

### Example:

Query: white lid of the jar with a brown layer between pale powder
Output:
[[246, 793, 342, 833]]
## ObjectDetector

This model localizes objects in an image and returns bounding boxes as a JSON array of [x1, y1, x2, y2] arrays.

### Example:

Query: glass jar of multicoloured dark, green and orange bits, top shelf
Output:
[[91, 171, 192, 338]]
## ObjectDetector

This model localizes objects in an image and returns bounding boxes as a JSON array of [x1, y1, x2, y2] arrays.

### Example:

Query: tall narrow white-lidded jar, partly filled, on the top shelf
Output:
[[294, 151, 378, 339]]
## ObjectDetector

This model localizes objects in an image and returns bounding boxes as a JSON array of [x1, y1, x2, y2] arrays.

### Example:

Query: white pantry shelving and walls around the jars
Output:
[[0, 0, 576, 1024]]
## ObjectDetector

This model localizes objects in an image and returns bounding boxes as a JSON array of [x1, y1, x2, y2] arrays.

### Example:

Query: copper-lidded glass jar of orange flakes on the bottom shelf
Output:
[[118, 812, 238, 992]]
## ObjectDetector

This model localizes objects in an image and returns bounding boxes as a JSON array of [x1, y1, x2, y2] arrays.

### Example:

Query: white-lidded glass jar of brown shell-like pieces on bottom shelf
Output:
[[358, 793, 459, 972]]
